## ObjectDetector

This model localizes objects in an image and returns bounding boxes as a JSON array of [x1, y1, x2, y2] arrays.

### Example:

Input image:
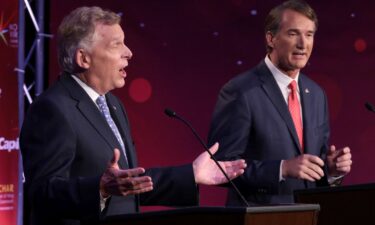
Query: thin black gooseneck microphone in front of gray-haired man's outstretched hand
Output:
[[164, 108, 250, 207]]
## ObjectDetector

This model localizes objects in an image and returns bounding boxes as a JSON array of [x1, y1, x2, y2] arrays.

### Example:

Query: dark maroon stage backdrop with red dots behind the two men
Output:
[[48, 0, 375, 208]]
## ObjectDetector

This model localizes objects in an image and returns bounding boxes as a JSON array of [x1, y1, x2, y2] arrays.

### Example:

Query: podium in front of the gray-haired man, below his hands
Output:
[[101, 204, 319, 225]]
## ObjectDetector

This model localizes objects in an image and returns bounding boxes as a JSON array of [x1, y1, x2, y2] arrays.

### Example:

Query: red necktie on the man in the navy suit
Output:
[[288, 80, 303, 152]]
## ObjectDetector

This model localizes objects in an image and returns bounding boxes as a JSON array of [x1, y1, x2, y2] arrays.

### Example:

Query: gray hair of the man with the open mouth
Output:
[[57, 6, 121, 73]]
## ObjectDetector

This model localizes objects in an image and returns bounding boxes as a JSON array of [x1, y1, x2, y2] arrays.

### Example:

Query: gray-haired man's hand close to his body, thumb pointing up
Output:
[[100, 149, 153, 198]]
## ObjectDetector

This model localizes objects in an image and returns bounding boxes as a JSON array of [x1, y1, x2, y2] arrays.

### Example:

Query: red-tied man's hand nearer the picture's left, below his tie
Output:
[[282, 154, 324, 182]]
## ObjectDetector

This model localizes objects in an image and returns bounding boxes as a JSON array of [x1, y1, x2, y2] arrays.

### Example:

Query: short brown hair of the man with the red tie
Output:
[[264, 0, 318, 52]]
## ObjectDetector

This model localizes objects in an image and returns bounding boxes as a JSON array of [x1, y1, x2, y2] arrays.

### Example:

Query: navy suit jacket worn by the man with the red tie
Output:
[[208, 61, 329, 205]]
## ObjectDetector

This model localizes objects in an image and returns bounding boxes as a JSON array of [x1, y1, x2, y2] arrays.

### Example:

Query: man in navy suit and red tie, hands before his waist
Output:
[[209, 1, 352, 205]]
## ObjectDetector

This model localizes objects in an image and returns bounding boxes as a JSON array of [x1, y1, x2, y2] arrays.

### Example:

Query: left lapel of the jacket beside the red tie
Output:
[[255, 62, 301, 153]]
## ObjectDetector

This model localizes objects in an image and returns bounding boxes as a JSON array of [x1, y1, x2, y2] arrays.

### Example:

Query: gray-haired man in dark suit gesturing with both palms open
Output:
[[21, 7, 246, 225]]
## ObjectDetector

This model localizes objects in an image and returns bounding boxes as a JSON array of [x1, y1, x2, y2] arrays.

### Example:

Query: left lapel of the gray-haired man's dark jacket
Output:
[[60, 74, 126, 168]]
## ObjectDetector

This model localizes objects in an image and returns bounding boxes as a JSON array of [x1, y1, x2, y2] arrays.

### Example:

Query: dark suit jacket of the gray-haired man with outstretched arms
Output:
[[20, 74, 198, 225]]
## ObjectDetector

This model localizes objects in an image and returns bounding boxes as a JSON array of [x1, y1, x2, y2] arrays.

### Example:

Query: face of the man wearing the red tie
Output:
[[266, 10, 315, 77]]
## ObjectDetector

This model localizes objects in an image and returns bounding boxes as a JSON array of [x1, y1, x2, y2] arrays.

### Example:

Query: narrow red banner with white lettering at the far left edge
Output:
[[0, 0, 19, 225]]
